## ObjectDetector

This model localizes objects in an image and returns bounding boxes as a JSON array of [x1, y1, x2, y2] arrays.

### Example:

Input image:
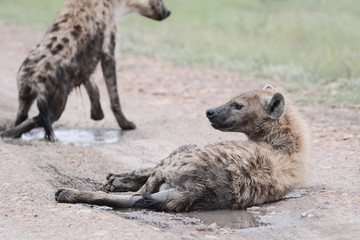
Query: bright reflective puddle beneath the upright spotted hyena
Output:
[[21, 129, 122, 146]]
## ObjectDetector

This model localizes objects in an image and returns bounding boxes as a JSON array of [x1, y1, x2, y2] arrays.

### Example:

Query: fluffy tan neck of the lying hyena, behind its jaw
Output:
[[248, 106, 308, 155]]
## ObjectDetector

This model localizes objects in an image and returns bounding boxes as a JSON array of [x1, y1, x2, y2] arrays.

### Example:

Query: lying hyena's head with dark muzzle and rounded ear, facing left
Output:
[[206, 85, 286, 136]]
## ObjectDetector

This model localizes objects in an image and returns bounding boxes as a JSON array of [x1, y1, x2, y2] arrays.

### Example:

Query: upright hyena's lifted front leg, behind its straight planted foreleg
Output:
[[84, 78, 104, 121]]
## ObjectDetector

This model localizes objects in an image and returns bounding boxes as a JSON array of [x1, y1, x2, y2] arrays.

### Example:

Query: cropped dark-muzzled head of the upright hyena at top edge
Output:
[[122, 0, 171, 21]]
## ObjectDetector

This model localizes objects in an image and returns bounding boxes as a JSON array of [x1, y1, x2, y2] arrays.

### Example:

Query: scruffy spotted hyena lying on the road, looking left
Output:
[[55, 87, 307, 212]]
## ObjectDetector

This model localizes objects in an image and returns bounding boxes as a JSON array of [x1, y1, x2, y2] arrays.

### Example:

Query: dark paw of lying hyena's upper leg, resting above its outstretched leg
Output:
[[104, 174, 143, 192]]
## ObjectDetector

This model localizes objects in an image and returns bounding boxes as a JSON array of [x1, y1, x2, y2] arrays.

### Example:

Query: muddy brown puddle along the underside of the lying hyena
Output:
[[183, 210, 269, 229]]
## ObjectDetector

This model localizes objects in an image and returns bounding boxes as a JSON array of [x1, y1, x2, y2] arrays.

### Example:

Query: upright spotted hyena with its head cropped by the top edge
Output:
[[2, 0, 170, 141]]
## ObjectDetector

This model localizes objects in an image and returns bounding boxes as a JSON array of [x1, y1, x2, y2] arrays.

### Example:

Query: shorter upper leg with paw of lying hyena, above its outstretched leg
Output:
[[104, 168, 153, 192]]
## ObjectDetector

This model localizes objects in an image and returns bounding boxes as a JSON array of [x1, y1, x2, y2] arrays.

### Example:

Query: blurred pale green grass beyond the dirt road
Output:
[[0, 0, 360, 106]]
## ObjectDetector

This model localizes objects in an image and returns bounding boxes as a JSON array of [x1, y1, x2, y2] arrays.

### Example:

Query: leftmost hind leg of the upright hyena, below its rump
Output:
[[15, 84, 36, 126]]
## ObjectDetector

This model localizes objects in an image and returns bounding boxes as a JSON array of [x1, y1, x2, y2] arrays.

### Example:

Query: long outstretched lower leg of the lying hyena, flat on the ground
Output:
[[55, 188, 179, 210]]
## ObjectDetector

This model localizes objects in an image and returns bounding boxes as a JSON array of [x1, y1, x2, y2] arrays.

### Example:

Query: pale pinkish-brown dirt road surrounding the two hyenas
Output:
[[0, 23, 360, 239]]
